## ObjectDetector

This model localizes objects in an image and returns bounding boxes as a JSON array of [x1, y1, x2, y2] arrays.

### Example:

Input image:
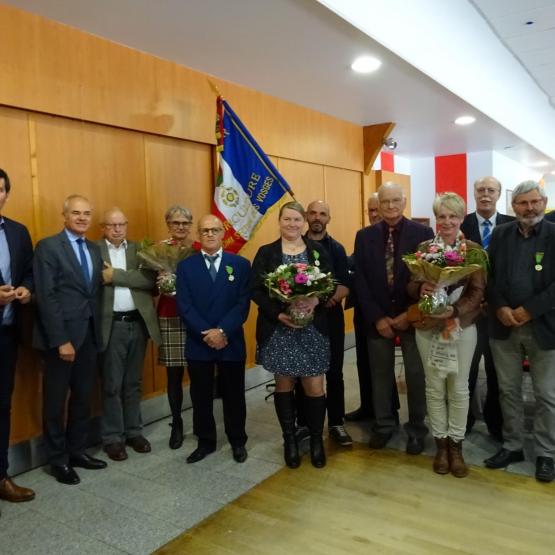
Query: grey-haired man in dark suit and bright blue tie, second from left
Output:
[[33, 195, 106, 484]]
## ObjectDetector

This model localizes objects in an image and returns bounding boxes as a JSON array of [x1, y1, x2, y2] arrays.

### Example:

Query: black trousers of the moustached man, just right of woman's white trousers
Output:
[[468, 318, 503, 434]]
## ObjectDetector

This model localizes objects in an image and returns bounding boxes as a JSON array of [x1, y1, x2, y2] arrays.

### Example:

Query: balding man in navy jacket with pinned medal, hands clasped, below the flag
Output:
[[176, 215, 251, 463]]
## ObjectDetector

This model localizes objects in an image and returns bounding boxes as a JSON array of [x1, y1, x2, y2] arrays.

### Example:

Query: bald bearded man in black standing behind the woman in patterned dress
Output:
[[295, 200, 353, 447]]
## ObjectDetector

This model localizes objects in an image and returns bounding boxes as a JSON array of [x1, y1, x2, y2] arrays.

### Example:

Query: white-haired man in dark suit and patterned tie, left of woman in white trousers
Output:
[[355, 183, 434, 454]]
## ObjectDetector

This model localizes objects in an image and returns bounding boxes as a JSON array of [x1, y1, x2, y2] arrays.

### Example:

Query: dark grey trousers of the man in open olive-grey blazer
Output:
[[102, 320, 148, 445]]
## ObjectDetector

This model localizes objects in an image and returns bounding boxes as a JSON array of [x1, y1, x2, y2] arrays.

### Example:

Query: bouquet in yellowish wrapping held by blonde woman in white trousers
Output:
[[403, 232, 488, 315]]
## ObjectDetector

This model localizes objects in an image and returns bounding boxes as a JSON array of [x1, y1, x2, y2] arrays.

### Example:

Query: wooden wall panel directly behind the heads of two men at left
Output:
[[32, 114, 147, 239]]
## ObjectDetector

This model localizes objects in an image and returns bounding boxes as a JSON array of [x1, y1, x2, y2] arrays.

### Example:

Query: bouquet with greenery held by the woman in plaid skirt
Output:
[[137, 239, 195, 296]]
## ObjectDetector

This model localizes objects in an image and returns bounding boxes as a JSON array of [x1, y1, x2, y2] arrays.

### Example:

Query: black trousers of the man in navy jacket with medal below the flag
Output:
[[187, 360, 247, 449]]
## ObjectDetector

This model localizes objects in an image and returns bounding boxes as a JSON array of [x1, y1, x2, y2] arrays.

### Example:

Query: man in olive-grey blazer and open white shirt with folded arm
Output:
[[98, 208, 161, 461]]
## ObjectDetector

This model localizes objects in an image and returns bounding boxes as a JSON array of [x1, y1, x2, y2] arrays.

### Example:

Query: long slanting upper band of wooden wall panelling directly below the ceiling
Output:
[[0, 6, 363, 171]]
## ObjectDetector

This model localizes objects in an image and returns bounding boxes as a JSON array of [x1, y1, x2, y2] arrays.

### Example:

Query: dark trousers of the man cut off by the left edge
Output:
[[0, 326, 17, 480]]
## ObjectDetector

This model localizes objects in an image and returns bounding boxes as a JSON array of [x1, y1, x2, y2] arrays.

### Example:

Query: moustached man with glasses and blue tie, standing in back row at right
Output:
[[461, 177, 514, 440]]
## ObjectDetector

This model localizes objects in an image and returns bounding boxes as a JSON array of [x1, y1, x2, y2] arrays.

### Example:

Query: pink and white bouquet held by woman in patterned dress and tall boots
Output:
[[264, 257, 335, 326]]
